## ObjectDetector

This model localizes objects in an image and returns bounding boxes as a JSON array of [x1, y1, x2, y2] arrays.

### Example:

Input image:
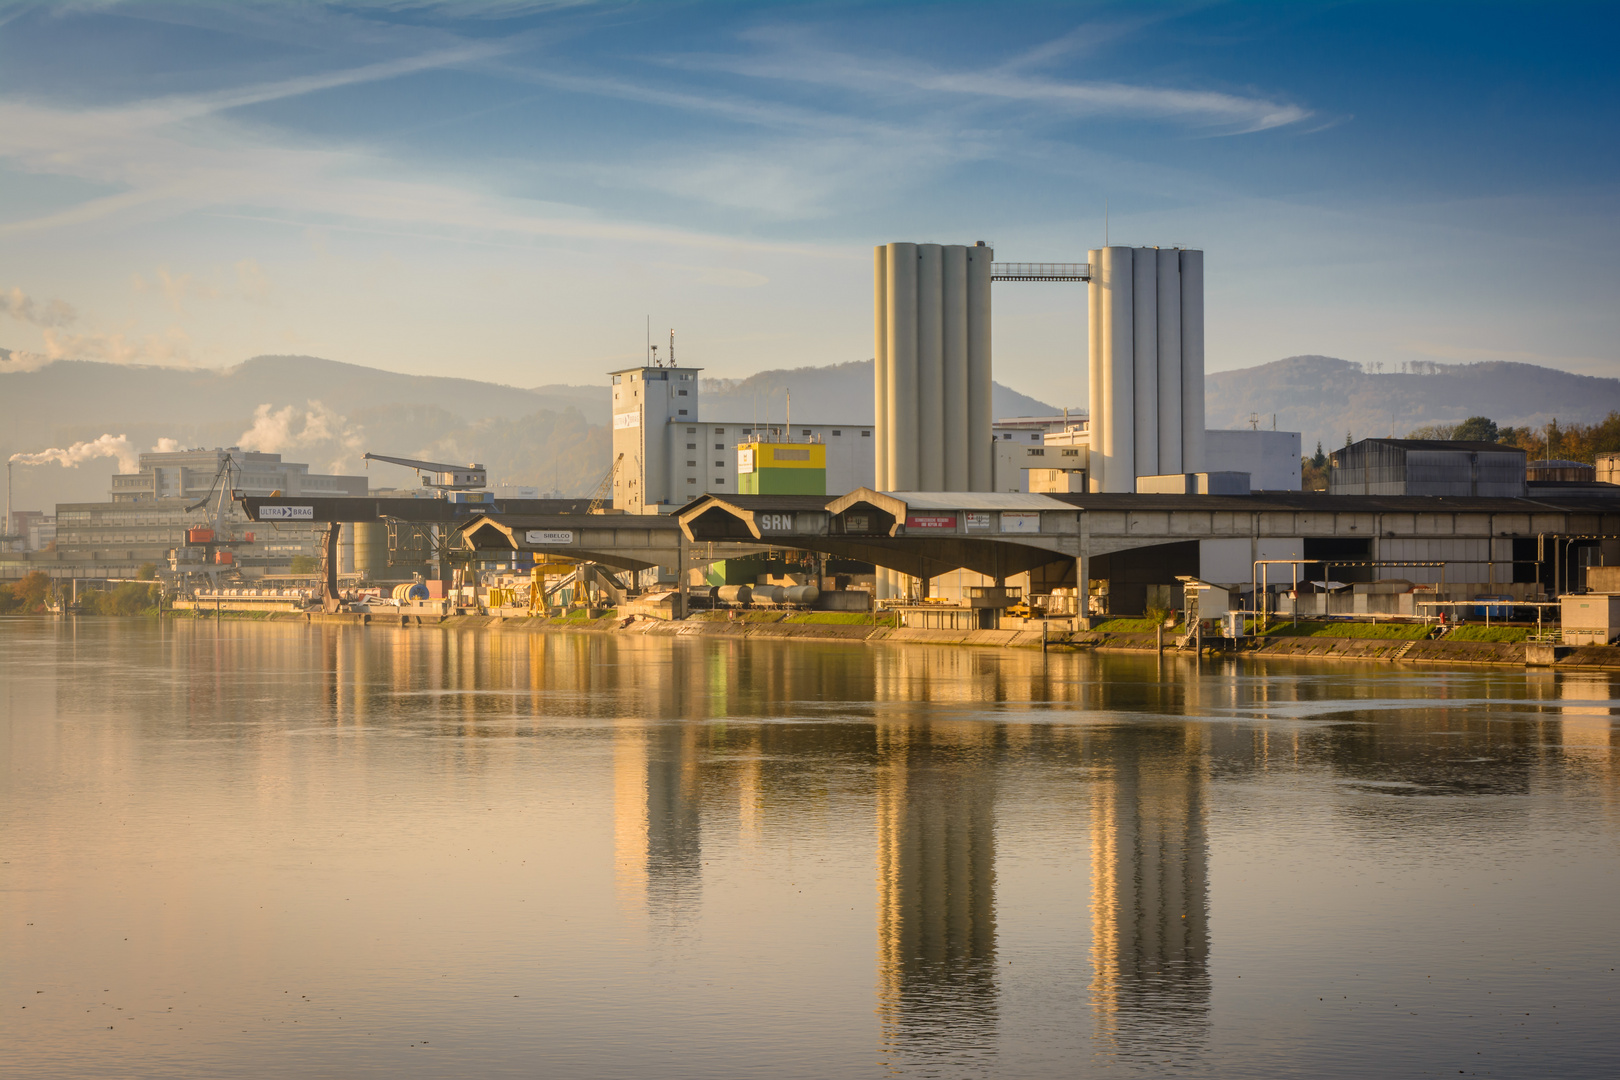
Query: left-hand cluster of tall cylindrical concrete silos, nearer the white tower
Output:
[[872, 243, 995, 491]]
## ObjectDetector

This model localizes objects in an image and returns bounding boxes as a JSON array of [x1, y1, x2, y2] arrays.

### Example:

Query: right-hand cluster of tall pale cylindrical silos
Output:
[[1087, 248, 1204, 492]]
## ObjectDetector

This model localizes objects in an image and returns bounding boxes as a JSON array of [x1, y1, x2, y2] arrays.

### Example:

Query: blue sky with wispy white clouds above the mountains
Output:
[[0, 0, 1620, 406]]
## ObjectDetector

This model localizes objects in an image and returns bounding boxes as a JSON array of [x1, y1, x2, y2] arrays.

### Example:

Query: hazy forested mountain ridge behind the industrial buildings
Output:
[[0, 350, 1620, 508]]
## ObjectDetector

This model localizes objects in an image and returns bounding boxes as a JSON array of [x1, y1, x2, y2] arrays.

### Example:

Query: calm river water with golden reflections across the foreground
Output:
[[0, 619, 1620, 1077]]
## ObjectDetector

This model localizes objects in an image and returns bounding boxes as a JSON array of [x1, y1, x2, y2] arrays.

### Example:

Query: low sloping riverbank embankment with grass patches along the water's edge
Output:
[[167, 612, 1620, 670]]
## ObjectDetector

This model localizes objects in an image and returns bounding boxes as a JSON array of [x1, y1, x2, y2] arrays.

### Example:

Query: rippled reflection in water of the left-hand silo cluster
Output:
[[876, 724, 996, 1067]]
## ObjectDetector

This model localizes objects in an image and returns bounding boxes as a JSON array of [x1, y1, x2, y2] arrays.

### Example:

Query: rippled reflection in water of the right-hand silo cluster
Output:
[[1087, 724, 1210, 1057]]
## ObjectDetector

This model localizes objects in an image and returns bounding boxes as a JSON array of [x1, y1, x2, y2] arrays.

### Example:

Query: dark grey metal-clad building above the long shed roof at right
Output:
[[1327, 439, 1528, 499]]
